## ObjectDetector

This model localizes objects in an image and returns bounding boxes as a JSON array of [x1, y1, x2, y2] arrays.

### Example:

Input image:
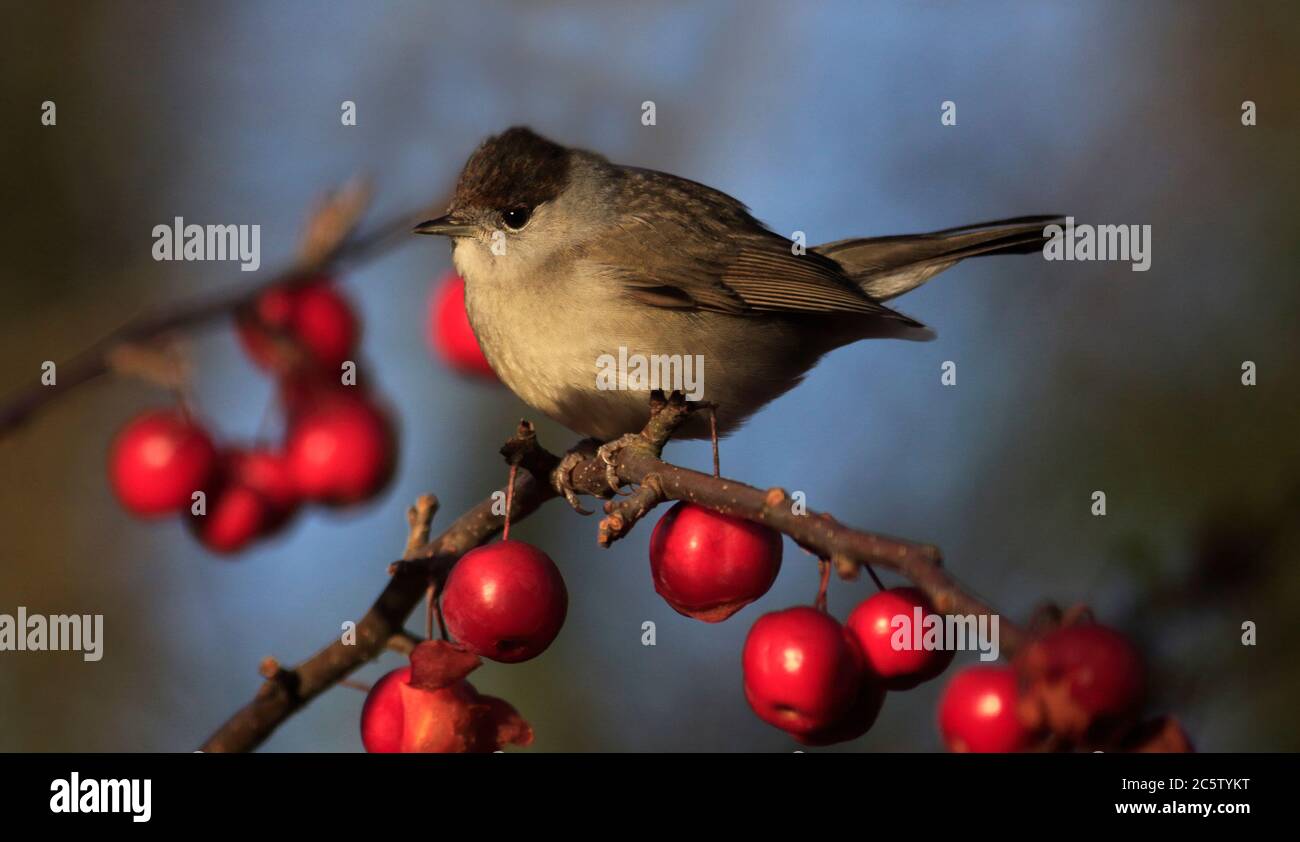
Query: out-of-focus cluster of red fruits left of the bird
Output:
[[108, 279, 397, 554]]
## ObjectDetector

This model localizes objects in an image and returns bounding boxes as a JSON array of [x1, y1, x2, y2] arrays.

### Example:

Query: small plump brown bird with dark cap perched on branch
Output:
[[416, 127, 1060, 440]]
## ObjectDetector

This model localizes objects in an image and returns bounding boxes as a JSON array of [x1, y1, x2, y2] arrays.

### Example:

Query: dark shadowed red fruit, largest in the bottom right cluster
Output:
[[1017, 622, 1147, 739]]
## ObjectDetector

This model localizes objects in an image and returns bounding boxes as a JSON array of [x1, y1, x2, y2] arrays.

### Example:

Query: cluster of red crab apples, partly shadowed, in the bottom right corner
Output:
[[939, 622, 1192, 752]]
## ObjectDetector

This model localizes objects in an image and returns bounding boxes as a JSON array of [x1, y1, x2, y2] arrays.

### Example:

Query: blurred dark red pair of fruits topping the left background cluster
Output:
[[239, 279, 361, 370]]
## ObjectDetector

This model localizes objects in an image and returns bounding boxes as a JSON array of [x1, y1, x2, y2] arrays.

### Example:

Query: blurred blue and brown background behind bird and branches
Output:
[[0, 0, 1300, 751]]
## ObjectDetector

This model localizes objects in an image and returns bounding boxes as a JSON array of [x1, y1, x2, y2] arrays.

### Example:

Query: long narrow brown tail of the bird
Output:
[[814, 216, 1063, 301]]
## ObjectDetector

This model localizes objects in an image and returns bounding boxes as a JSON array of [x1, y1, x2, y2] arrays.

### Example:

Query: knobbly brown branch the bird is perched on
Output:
[[203, 395, 1024, 751]]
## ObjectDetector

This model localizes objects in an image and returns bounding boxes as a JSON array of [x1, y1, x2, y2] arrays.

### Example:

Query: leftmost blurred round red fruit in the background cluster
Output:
[[108, 409, 217, 517]]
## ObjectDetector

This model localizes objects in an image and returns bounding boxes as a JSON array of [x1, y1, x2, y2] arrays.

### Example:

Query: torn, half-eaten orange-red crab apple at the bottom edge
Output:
[[361, 641, 533, 752]]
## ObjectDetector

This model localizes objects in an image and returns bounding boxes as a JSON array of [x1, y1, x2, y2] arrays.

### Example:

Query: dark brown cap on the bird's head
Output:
[[451, 126, 569, 212]]
